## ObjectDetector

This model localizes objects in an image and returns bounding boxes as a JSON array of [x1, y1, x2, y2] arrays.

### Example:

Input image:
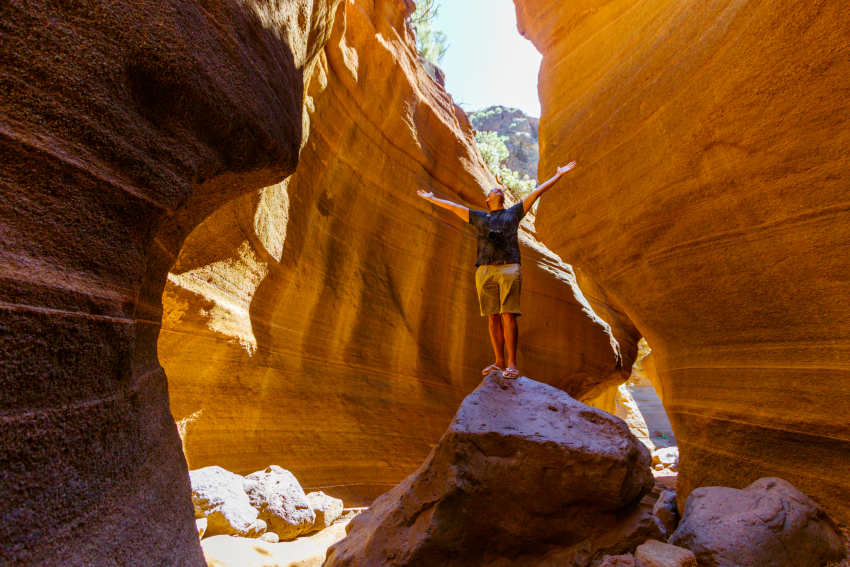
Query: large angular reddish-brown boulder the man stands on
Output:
[[326, 376, 657, 567]]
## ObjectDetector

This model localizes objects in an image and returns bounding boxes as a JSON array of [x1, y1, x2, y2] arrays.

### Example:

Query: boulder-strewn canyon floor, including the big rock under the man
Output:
[[190, 373, 850, 567]]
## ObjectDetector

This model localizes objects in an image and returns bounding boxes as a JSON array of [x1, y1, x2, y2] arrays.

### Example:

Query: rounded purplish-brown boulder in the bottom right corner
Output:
[[670, 478, 844, 567]]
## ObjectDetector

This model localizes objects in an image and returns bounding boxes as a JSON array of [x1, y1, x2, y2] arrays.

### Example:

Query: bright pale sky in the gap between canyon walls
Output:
[[433, 0, 541, 117]]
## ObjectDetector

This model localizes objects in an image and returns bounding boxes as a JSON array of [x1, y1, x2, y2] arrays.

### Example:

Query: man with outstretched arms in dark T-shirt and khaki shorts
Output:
[[417, 162, 576, 378]]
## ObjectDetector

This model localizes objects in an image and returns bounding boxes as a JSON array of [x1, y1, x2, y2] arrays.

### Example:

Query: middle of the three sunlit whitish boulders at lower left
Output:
[[242, 465, 316, 539]]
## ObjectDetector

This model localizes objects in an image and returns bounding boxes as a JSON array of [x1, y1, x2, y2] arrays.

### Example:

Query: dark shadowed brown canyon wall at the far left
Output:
[[0, 0, 336, 565]]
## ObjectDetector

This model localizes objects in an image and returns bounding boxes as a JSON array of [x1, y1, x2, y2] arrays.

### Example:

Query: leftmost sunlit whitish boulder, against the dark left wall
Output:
[[189, 467, 260, 537]]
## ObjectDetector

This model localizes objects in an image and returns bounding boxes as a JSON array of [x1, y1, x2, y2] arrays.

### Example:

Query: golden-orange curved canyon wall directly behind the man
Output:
[[159, 0, 633, 505]]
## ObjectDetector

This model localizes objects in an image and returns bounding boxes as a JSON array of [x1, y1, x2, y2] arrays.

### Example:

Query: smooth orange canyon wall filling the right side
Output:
[[515, 0, 850, 522]]
